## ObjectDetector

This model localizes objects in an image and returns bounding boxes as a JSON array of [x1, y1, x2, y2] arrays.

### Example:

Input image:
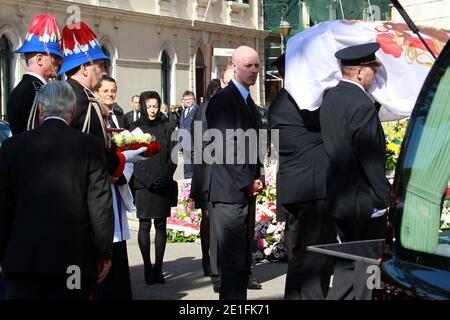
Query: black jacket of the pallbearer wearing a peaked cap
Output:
[[320, 81, 390, 220]]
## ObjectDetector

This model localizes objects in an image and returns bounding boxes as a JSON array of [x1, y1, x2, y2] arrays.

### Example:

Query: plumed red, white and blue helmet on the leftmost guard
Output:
[[15, 14, 63, 58]]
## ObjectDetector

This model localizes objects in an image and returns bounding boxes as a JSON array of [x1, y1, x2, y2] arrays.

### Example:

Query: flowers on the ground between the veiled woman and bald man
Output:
[[167, 182, 201, 242]]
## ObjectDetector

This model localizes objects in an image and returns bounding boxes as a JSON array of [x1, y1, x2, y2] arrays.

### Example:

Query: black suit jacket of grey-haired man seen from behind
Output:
[[0, 119, 114, 279]]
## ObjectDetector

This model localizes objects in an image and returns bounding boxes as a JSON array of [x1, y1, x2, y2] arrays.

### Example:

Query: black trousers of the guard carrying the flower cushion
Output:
[[94, 241, 133, 300]]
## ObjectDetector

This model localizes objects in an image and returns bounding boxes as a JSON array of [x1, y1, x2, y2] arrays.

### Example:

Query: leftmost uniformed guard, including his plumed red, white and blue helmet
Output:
[[6, 14, 62, 134]]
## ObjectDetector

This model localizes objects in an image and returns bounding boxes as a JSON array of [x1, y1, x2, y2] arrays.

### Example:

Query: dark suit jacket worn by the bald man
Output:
[[204, 82, 262, 204]]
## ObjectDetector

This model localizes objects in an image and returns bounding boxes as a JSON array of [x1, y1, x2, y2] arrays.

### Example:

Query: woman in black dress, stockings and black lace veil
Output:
[[130, 91, 177, 284]]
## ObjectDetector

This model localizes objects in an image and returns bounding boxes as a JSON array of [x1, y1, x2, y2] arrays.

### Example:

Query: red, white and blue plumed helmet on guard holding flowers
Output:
[[58, 21, 109, 75]]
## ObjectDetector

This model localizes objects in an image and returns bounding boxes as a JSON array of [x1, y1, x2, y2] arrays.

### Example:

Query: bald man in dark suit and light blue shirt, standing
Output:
[[204, 46, 264, 300]]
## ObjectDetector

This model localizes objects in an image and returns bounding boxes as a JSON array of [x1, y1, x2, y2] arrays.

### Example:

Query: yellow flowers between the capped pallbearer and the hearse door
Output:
[[383, 120, 408, 171]]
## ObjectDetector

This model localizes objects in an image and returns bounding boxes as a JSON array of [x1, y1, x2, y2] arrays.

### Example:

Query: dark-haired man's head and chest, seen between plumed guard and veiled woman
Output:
[[98, 76, 126, 129]]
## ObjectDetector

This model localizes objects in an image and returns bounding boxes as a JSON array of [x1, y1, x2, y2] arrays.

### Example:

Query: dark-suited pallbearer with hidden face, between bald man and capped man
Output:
[[268, 56, 336, 300]]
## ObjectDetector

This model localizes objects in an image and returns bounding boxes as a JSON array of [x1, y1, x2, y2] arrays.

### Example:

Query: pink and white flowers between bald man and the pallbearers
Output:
[[254, 167, 286, 261]]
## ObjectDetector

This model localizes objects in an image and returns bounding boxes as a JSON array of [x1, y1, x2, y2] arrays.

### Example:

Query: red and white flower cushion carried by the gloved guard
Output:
[[111, 128, 160, 157]]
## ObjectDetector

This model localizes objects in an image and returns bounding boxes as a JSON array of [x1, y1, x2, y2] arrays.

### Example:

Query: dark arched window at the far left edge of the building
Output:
[[0, 35, 13, 119]]
